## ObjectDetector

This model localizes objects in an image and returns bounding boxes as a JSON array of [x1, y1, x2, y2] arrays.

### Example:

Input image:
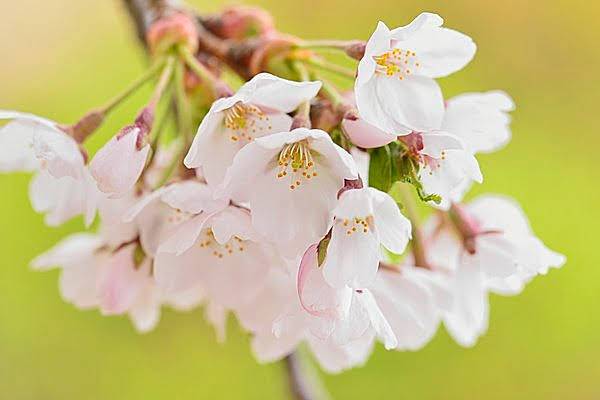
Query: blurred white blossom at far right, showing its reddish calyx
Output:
[[420, 195, 565, 346]]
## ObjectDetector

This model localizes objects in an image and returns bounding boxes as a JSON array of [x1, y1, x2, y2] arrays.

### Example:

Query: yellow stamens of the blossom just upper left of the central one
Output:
[[225, 102, 272, 142]]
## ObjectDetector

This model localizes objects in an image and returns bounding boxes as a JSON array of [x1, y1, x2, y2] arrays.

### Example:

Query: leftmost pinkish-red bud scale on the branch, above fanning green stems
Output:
[[146, 12, 198, 54]]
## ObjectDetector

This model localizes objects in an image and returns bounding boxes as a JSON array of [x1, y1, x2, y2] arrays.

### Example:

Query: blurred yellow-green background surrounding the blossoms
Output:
[[0, 0, 600, 400]]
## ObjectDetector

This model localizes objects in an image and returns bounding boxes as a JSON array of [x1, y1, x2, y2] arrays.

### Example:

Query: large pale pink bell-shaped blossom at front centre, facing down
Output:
[[217, 128, 358, 257]]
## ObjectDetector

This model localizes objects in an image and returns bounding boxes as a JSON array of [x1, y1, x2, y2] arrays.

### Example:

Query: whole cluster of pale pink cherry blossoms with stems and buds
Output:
[[0, 7, 565, 372]]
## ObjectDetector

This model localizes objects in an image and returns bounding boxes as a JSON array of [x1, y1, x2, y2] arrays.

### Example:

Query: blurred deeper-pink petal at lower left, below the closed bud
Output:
[[96, 245, 150, 315]]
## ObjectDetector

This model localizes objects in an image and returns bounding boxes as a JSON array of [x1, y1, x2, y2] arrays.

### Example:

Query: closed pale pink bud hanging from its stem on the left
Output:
[[90, 128, 150, 197]]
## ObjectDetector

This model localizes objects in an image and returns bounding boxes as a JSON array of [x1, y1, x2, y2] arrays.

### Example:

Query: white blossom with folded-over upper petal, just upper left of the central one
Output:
[[184, 73, 321, 186]]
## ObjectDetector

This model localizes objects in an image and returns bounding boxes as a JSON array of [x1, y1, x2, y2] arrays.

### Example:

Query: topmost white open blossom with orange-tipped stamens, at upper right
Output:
[[355, 13, 476, 135]]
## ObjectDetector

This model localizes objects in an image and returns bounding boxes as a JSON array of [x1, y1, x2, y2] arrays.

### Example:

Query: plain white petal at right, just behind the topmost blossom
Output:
[[442, 91, 514, 153]]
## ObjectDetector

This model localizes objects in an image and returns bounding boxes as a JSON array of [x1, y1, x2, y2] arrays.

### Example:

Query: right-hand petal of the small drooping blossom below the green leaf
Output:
[[368, 188, 412, 254]]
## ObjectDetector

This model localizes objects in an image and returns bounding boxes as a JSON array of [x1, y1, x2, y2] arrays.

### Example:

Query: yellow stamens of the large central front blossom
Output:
[[277, 140, 317, 190]]
